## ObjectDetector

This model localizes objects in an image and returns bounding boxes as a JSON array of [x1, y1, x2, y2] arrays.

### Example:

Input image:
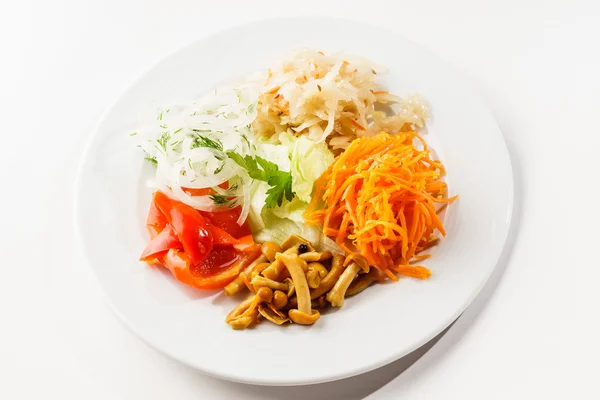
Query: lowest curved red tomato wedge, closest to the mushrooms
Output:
[[163, 245, 260, 289]]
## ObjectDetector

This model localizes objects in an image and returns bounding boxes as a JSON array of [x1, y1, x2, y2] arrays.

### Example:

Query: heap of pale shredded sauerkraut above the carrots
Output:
[[252, 49, 428, 150]]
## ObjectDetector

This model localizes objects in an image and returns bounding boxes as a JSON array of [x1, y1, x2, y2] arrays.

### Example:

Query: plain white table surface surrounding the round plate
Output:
[[0, 0, 600, 400]]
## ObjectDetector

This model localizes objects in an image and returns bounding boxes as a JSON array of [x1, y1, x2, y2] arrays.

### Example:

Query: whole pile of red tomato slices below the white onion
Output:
[[140, 191, 260, 289]]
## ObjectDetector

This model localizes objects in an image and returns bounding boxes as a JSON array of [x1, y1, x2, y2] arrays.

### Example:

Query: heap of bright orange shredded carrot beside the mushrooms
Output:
[[304, 131, 456, 280]]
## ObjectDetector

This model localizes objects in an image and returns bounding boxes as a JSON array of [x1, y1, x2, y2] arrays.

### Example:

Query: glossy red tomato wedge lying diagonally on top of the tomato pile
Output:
[[154, 191, 213, 265]]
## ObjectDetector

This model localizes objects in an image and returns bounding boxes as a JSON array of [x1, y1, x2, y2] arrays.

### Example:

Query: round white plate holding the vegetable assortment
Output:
[[75, 18, 513, 385]]
